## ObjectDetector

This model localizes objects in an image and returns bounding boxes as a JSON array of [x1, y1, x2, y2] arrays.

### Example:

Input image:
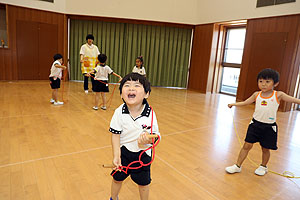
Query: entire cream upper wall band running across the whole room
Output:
[[1, 0, 300, 24]]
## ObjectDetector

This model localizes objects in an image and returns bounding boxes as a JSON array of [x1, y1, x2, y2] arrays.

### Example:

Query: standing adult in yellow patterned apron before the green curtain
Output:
[[80, 34, 100, 94]]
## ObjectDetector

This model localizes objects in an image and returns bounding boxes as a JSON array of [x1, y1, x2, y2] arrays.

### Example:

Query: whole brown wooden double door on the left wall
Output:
[[17, 21, 58, 80]]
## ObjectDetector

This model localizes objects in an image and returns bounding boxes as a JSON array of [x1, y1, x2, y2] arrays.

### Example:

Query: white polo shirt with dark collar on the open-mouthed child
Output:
[[109, 103, 160, 156]]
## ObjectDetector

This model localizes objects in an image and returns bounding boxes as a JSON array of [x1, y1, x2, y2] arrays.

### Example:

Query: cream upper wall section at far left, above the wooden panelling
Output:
[[0, 0, 66, 13]]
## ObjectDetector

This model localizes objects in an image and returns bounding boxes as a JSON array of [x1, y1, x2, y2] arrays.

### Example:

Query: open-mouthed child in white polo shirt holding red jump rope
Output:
[[109, 73, 160, 200]]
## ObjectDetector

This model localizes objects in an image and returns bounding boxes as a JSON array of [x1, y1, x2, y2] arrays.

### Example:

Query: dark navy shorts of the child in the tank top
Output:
[[245, 119, 278, 150]]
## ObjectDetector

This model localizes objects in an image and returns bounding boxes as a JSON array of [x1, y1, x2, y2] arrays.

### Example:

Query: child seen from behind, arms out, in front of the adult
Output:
[[87, 54, 122, 110]]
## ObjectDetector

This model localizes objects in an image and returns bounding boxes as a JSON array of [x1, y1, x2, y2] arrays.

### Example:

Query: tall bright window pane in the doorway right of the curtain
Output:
[[220, 27, 246, 95]]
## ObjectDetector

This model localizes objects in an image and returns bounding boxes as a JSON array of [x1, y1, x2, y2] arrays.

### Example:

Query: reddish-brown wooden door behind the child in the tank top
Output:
[[245, 32, 287, 97]]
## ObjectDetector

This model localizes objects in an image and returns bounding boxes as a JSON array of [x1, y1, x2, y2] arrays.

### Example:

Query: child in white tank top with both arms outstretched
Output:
[[225, 69, 300, 176]]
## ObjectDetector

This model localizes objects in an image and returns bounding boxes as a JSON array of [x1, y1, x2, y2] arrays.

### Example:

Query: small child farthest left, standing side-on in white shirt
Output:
[[49, 54, 66, 106]]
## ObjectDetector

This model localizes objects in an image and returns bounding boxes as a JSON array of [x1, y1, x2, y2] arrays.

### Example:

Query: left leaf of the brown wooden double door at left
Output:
[[17, 20, 39, 80]]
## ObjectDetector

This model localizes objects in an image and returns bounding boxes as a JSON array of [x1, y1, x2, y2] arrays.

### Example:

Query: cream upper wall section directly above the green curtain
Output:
[[66, 0, 197, 24]]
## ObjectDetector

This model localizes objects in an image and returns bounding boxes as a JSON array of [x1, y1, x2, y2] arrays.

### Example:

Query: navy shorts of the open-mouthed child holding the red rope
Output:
[[111, 146, 151, 185]]
